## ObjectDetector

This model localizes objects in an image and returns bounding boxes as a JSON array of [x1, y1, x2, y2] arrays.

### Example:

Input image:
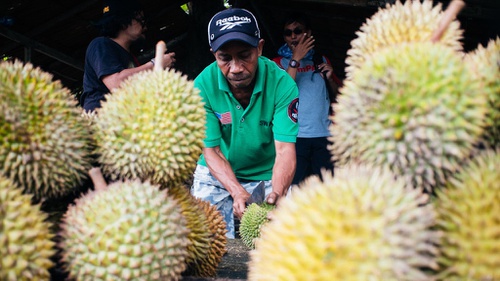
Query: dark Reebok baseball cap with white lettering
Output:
[[208, 8, 260, 52]]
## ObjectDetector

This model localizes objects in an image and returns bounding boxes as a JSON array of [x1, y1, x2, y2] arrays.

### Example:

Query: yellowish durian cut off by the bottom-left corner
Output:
[[0, 175, 55, 281]]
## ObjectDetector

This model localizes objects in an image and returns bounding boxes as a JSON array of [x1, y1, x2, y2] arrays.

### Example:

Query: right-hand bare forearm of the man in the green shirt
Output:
[[266, 141, 297, 204]]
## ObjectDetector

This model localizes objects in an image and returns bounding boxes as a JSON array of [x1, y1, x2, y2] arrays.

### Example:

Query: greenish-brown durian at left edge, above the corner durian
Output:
[[0, 61, 92, 199]]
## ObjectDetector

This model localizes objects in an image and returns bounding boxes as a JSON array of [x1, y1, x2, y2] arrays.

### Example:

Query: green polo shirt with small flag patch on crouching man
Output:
[[194, 57, 299, 180]]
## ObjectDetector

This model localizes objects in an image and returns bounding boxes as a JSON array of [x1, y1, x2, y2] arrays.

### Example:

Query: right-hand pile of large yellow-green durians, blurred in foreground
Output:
[[248, 0, 500, 281]]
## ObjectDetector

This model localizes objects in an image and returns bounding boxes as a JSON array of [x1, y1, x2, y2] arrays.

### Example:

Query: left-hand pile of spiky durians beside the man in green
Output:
[[0, 42, 226, 281]]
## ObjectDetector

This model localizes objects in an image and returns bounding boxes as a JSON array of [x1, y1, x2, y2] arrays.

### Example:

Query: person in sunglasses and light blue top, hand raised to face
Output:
[[273, 13, 341, 185]]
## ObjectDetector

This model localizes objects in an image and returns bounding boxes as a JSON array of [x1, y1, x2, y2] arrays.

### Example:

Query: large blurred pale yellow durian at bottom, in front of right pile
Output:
[[248, 166, 440, 281]]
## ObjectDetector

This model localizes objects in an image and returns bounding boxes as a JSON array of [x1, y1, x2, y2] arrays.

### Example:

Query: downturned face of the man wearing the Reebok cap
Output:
[[214, 39, 264, 89]]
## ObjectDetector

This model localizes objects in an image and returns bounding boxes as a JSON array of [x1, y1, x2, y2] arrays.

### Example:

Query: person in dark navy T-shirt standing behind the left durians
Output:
[[80, 0, 175, 111]]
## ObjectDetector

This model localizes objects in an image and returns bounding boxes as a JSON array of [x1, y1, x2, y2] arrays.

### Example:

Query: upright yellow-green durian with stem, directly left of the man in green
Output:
[[95, 43, 205, 186]]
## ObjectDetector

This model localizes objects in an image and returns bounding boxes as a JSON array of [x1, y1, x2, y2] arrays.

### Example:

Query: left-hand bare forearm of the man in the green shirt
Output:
[[203, 146, 250, 218]]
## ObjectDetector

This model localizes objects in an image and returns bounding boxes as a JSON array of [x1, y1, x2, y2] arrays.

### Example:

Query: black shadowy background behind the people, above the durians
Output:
[[0, 0, 500, 92]]
